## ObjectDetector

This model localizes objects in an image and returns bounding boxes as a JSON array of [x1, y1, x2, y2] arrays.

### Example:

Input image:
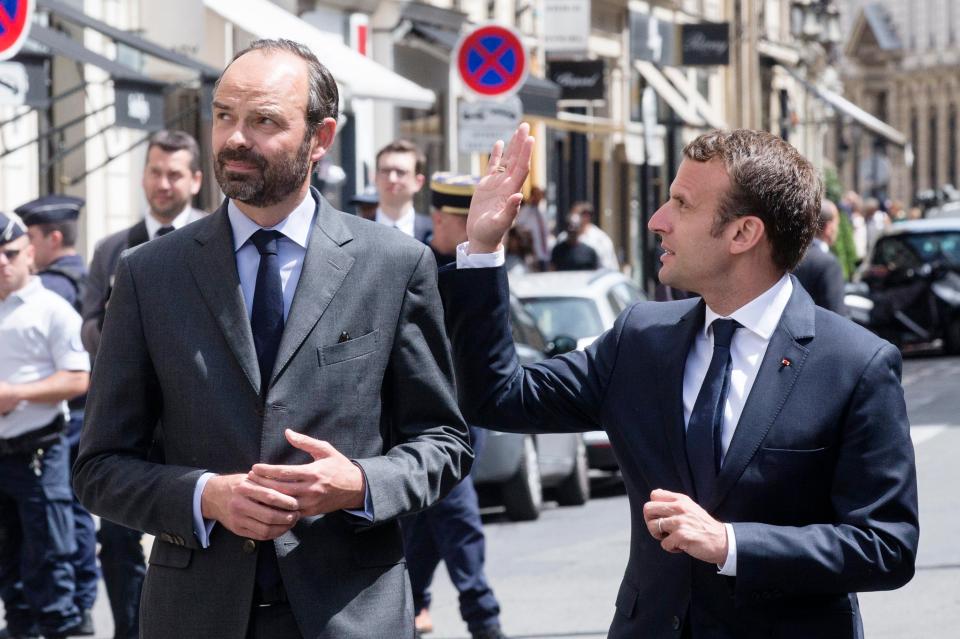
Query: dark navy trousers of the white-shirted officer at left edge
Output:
[[0, 436, 80, 635]]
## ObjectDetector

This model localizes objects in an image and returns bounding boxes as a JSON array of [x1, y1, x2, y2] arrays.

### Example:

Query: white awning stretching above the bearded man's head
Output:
[[203, 0, 436, 109]]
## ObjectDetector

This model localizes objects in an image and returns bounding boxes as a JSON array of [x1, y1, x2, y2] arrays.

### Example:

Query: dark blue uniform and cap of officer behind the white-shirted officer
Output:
[[14, 195, 100, 634]]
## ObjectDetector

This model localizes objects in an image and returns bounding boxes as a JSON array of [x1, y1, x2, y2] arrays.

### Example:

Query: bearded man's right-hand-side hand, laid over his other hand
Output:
[[247, 428, 366, 516]]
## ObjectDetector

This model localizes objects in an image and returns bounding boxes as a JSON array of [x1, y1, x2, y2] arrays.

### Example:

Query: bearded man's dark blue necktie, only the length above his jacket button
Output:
[[250, 229, 283, 397]]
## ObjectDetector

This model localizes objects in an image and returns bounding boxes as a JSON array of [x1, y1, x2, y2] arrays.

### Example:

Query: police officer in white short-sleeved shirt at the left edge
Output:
[[0, 213, 90, 639]]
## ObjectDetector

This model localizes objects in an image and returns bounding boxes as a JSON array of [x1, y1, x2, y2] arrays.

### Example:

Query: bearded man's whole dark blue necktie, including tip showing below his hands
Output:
[[250, 229, 283, 593]]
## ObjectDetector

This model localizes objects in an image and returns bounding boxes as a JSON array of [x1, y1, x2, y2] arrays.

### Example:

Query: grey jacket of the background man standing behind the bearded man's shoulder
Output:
[[81, 208, 207, 357]]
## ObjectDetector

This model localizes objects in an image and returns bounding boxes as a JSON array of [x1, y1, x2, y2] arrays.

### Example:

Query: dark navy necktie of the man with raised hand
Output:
[[687, 319, 740, 504]]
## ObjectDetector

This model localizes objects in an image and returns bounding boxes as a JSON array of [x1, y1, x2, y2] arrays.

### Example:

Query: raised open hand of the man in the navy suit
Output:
[[467, 122, 533, 253]]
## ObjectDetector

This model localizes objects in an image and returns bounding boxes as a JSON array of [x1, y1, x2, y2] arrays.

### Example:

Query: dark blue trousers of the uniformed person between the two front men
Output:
[[403, 428, 500, 632]]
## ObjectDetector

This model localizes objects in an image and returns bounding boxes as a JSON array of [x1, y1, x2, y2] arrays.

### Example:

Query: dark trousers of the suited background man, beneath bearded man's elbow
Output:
[[97, 519, 147, 639]]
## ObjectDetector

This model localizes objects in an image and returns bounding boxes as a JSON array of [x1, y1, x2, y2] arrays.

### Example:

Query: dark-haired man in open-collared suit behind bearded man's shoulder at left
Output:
[[81, 131, 206, 639]]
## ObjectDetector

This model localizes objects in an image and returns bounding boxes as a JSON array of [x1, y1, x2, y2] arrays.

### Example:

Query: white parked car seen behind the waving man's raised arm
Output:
[[510, 271, 646, 470]]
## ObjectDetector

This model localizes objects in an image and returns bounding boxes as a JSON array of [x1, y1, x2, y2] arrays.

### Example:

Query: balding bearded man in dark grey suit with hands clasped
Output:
[[74, 40, 472, 639]]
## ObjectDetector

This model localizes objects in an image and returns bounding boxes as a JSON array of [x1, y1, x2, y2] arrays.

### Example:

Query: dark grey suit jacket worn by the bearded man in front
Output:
[[74, 192, 472, 639]]
